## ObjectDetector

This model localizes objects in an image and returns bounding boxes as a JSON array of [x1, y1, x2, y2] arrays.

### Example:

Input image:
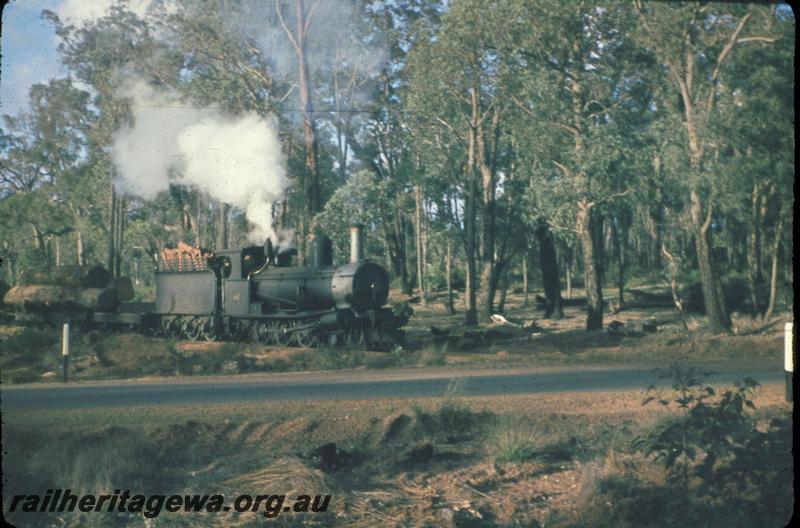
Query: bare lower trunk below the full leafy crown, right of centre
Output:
[[576, 200, 603, 330]]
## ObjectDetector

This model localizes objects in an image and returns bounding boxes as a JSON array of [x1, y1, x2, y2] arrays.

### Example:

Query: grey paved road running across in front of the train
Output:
[[0, 366, 783, 412]]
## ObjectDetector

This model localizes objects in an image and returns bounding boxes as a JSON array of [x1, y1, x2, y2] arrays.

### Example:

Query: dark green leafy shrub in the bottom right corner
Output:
[[634, 364, 793, 526]]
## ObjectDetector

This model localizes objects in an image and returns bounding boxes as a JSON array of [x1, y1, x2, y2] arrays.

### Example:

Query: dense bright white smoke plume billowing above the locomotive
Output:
[[112, 81, 289, 243]]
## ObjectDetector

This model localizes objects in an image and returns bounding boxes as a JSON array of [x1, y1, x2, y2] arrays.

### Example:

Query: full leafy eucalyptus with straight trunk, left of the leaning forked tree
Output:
[[512, 1, 632, 330]]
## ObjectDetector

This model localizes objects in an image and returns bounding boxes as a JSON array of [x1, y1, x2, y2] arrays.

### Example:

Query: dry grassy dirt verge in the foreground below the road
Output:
[[3, 388, 791, 527]]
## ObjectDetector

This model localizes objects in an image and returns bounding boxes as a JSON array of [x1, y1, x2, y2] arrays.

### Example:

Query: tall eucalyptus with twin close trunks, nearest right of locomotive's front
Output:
[[406, 0, 513, 324]]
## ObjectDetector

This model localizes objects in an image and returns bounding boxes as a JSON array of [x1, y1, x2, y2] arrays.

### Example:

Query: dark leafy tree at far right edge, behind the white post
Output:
[[714, 11, 794, 319]]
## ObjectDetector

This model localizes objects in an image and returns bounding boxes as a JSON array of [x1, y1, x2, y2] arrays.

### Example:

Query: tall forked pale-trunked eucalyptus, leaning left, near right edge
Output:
[[635, 0, 778, 331]]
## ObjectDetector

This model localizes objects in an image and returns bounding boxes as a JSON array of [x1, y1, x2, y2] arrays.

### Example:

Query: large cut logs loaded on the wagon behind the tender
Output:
[[3, 266, 134, 311]]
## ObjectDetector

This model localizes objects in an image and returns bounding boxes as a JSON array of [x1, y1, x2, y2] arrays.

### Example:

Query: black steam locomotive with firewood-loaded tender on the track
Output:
[[6, 225, 410, 349]]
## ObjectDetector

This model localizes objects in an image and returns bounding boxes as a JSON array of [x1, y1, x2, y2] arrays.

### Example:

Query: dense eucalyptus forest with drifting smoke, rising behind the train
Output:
[[0, 0, 795, 331]]
